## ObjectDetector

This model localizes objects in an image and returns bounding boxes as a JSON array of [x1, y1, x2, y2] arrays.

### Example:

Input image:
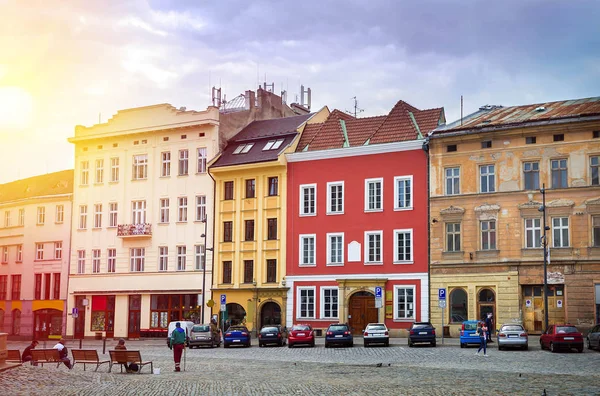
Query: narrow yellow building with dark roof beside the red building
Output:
[[209, 108, 329, 330]]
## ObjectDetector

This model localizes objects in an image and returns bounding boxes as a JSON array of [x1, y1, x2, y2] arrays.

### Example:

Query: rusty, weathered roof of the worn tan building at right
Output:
[[433, 97, 600, 137]]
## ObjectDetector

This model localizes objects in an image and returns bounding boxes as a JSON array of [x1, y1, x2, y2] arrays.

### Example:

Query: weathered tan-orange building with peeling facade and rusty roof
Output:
[[429, 98, 600, 336]]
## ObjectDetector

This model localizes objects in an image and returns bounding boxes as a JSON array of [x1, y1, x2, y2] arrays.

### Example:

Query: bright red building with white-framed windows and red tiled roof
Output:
[[286, 101, 444, 336]]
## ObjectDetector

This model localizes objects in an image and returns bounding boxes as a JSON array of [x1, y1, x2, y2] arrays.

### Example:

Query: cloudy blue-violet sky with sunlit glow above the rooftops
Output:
[[0, 0, 600, 183]]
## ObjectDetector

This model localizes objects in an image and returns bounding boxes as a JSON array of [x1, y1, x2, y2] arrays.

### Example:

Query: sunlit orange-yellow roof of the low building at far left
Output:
[[0, 169, 73, 203]]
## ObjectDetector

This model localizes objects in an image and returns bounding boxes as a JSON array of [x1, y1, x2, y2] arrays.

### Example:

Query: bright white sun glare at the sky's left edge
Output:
[[0, 87, 33, 129]]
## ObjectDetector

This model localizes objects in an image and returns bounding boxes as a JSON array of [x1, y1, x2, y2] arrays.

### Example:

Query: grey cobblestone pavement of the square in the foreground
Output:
[[0, 338, 600, 396]]
